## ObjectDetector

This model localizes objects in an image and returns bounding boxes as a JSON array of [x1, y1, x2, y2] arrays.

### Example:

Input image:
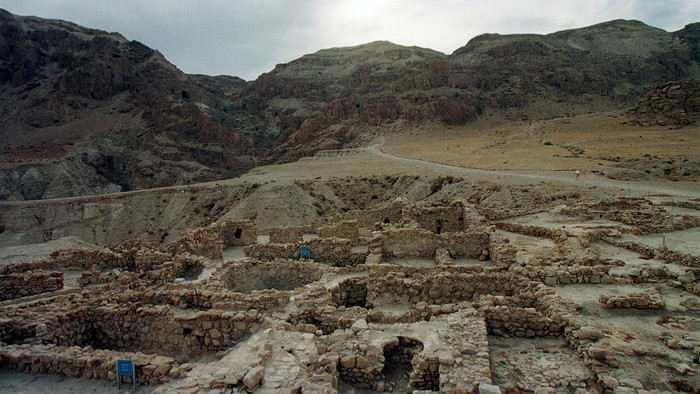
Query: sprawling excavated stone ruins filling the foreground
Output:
[[0, 198, 700, 393]]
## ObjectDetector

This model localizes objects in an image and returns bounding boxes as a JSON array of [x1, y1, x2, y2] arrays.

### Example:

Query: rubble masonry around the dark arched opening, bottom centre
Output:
[[317, 308, 491, 393]]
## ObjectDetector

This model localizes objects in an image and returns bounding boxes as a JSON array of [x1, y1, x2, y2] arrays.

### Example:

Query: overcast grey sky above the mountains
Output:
[[0, 0, 700, 80]]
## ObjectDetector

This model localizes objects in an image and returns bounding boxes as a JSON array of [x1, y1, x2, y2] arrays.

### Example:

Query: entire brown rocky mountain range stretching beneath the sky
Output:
[[0, 11, 700, 200]]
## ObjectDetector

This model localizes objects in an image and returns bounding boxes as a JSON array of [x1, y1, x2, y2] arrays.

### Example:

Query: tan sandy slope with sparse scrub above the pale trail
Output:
[[385, 113, 700, 177]]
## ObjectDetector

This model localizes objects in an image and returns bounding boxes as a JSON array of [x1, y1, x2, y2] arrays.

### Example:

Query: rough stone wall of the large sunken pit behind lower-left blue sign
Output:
[[35, 303, 261, 362]]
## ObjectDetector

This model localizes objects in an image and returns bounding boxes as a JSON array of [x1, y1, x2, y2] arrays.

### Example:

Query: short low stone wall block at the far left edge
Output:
[[0, 271, 63, 301]]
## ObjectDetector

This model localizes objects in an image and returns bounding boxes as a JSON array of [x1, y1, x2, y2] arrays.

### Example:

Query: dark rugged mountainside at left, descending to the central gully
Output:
[[0, 11, 254, 200]]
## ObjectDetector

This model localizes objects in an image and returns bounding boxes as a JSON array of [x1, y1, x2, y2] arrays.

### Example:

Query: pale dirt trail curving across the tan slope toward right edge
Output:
[[362, 136, 700, 198]]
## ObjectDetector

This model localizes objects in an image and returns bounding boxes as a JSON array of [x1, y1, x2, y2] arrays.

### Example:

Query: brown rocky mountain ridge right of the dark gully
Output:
[[242, 20, 700, 162]]
